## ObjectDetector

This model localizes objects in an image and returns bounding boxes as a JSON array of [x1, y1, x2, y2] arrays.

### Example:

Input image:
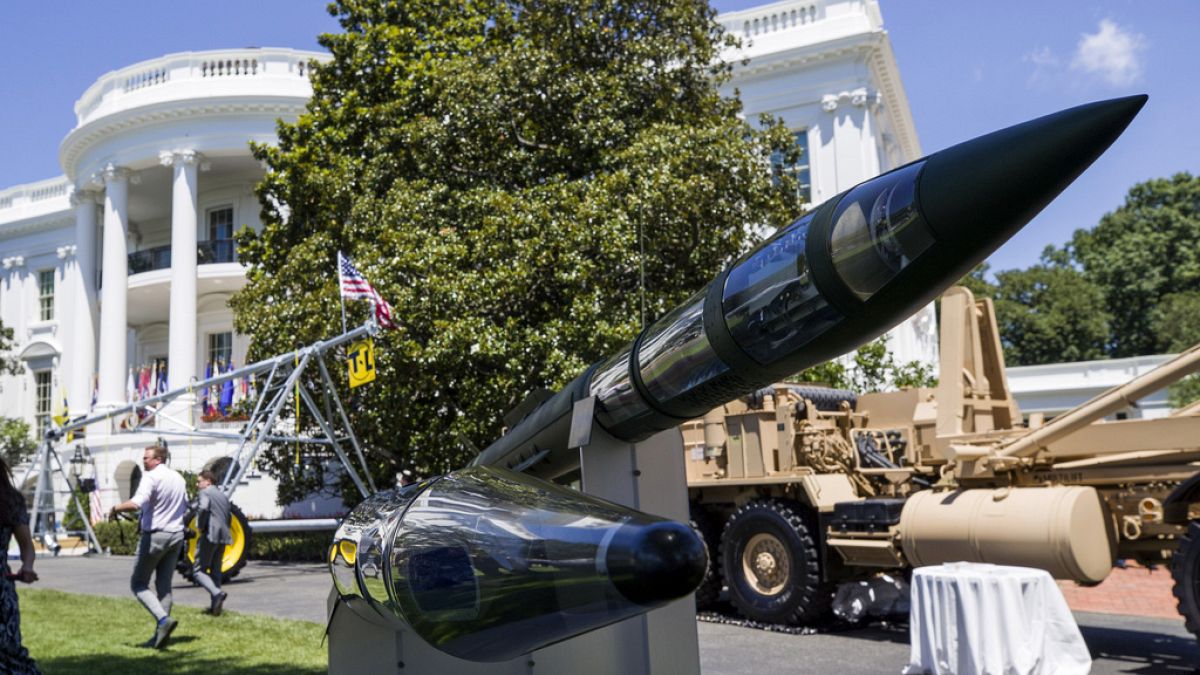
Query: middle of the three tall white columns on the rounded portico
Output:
[[96, 165, 130, 408]]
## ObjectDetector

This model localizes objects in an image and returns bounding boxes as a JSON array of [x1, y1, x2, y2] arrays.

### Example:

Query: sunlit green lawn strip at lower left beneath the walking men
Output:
[[19, 589, 328, 675]]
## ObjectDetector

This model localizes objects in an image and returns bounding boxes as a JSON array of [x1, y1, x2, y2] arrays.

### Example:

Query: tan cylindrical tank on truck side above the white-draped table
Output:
[[900, 485, 1115, 583]]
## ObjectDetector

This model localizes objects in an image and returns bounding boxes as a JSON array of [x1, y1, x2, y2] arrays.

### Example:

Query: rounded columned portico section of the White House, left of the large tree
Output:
[[0, 49, 328, 515]]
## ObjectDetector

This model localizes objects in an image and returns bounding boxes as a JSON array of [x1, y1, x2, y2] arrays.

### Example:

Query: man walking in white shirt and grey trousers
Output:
[[108, 446, 187, 649]]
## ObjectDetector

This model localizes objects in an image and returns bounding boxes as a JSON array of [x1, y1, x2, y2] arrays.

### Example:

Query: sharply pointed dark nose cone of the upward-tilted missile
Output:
[[918, 95, 1147, 260]]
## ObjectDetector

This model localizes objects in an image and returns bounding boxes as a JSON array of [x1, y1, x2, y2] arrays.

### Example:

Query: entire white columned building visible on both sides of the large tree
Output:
[[0, 0, 937, 516]]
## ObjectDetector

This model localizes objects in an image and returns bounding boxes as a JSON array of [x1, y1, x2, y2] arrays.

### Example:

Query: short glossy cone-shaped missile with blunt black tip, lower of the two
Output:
[[329, 466, 708, 662]]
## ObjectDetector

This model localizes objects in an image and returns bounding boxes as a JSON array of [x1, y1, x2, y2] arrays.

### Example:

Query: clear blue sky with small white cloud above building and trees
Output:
[[0, 0, 1200, 269]]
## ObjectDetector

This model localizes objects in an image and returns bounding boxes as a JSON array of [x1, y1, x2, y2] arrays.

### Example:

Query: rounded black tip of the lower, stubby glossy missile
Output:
[[605, 520, 708, 605]]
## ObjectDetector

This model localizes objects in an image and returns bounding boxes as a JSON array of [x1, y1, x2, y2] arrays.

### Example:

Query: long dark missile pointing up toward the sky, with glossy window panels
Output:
[[472, 96, 1147, 478]]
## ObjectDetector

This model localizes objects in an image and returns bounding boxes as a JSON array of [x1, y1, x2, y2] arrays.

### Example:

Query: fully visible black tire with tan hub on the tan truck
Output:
[[721, 500, 833, 623]]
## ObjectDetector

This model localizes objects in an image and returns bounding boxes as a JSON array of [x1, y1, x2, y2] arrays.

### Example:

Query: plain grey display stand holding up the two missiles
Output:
[[328, 398, 700, 675]]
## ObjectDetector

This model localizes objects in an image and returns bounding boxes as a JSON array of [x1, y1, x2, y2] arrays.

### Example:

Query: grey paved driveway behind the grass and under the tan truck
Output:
[[23, 556, 1200, 675]]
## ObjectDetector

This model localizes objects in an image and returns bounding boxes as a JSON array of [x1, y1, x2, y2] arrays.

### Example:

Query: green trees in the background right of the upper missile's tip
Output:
[[961, 173, 1200, 365]]
